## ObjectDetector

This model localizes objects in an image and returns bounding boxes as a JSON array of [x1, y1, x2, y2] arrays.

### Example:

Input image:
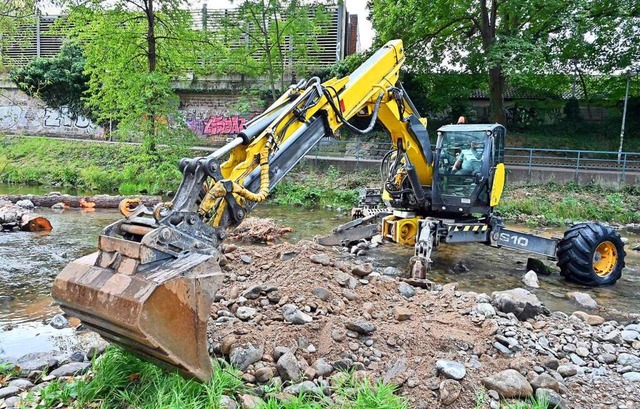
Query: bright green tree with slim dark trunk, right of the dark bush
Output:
[[60, 0, 211, 152]]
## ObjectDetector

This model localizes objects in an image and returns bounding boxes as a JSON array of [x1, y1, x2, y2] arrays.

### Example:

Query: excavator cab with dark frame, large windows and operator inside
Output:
[[432, 124, 505, 214]]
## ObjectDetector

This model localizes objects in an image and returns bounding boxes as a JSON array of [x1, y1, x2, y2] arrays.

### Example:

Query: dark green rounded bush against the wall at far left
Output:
[[10, 43, 96, 120]]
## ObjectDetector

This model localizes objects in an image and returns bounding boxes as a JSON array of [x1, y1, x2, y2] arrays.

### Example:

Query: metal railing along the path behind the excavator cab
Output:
[[309, 138, 640, 177]]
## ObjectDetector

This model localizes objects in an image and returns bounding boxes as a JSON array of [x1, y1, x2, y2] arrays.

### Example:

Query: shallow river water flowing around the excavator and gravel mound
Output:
[[0, 188, 640, 357]]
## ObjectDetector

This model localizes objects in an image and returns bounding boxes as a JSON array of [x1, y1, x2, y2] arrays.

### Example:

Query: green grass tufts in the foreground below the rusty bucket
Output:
[[23, 346, 407, 409]]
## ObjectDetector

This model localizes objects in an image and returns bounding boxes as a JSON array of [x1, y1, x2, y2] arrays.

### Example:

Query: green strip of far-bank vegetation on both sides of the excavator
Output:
[[0, 137, 640, 226]]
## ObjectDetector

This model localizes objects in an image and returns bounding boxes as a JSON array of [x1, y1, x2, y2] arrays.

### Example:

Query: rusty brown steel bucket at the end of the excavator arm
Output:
[[51, 207, 223, 382]]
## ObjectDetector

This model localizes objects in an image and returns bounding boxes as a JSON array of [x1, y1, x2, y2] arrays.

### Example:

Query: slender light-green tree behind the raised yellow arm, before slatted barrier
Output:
[[221, 0, 327, 100]]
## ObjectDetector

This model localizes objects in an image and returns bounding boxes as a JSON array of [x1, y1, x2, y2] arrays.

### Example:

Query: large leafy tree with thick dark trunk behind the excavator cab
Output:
[[369, 0, 637, 123]]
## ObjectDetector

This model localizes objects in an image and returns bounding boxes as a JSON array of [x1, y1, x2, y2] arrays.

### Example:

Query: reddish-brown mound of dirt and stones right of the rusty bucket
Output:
[[209, 226, 640, 408]]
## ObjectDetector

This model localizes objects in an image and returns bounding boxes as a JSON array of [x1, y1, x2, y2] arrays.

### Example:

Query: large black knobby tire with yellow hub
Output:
[[557, 223, 627, 287]]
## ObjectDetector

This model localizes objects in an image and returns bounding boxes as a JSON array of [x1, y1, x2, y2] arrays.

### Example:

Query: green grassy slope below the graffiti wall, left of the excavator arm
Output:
[[0, 136, 189, 194]]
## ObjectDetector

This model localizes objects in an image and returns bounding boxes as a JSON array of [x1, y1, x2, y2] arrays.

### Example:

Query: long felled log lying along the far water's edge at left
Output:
[[0, 194, 162, 209]]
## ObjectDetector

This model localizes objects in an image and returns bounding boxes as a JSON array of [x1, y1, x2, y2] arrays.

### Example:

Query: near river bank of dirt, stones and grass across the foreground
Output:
[[0, 240, 640, 409]]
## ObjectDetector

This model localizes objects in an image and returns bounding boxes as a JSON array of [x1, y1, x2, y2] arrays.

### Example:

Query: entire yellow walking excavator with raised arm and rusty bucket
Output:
[[52, 40, 625, 381]]
